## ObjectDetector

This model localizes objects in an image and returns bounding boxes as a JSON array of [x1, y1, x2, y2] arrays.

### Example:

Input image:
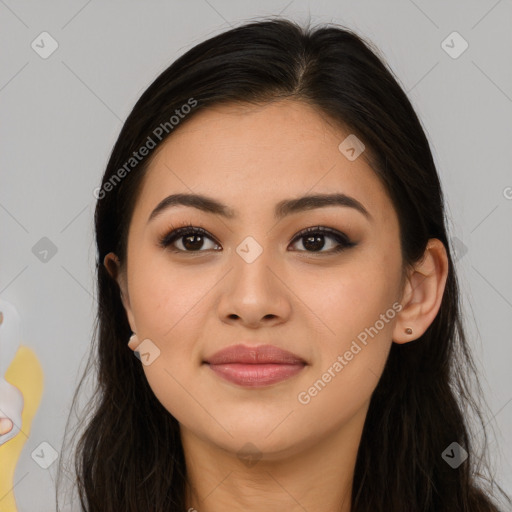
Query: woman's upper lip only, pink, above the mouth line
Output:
[[205, 344, 306, 364]]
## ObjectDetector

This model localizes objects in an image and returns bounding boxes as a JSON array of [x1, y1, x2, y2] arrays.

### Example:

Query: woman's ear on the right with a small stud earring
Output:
[[393, 238, 448, 343]]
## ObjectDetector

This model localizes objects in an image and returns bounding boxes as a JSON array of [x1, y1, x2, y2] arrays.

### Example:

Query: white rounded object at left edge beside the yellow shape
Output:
[[0, 298, 24, 446]]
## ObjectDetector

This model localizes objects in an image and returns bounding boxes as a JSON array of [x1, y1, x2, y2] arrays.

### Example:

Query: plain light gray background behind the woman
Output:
[[0, 0, 512, 512]]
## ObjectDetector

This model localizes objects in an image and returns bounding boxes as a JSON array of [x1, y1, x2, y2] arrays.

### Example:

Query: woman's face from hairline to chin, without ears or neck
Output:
[[115, 100, 402, 459]]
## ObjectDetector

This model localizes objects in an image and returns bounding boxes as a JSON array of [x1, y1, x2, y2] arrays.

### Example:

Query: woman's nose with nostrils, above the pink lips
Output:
[[218, 247, 293, 329]]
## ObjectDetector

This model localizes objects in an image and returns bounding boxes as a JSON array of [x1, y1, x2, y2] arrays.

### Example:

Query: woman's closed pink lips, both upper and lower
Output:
[[205, 345, 306, 387]]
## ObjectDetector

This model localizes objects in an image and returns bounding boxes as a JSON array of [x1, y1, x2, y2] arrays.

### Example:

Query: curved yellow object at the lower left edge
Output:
[[0, 345, 44, 512]]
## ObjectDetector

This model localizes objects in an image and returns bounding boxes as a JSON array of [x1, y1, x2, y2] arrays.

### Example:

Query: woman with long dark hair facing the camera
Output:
[[59, 19, 510, 512]]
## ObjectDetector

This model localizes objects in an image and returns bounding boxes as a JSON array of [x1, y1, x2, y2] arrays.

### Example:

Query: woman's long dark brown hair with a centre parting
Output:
[[57, 17, 511, 512]]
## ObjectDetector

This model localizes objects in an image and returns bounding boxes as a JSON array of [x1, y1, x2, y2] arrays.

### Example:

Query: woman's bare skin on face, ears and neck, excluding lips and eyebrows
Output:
[[104, 100, 448, 512]]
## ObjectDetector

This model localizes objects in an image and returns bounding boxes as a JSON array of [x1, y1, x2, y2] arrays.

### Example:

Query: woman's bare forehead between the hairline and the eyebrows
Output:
[[137, 100, 393, 225]]
